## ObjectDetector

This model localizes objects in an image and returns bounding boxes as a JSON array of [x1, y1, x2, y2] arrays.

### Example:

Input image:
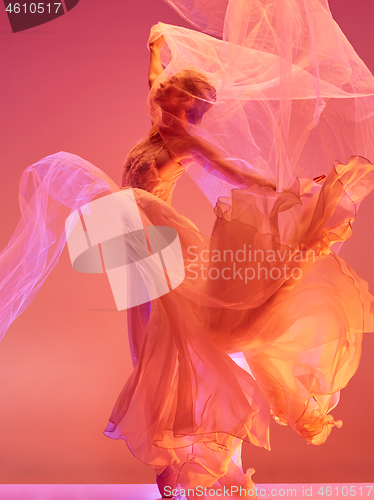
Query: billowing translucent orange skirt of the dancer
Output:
[[105, 157, 374, 487]]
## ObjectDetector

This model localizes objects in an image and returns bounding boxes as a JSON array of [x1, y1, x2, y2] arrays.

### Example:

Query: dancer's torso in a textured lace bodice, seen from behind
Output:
[[122, 128, 184, 203]]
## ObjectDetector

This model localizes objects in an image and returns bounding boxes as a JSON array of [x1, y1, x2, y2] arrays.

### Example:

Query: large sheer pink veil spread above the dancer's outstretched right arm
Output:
[[151, 0, 374, 203]]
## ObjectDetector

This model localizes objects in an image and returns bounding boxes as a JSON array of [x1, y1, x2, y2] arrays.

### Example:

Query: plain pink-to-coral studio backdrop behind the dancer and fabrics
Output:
[[0, 0, 374, 483]]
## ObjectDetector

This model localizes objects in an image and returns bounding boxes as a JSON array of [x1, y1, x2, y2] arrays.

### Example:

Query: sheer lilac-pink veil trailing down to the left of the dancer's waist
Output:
[[0, 152, 120, 340]]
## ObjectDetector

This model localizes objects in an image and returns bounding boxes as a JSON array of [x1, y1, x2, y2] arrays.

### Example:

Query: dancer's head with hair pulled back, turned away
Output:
[[154, 70, 216, 124]]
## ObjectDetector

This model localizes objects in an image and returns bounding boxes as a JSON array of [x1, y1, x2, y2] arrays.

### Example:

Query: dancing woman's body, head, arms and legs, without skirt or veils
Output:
[[105, 32, 275, 496]]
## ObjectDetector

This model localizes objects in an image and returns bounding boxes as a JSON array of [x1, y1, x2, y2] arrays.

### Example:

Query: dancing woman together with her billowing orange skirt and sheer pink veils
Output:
[[0, 0, 374, 500]]
